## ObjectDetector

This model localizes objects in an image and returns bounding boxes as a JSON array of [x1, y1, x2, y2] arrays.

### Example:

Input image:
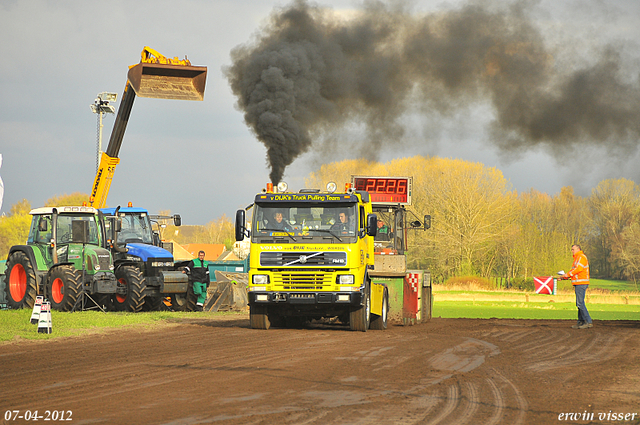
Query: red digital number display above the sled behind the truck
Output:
[[351, 176, 413, 205]]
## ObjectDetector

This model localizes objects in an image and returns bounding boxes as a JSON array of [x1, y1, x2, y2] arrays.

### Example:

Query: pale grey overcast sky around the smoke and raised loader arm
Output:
[[0, 0, 640, 224]]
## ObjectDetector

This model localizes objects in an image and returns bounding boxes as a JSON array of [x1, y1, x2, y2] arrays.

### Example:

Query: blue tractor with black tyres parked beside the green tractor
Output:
[[100, 204, 189, 312]]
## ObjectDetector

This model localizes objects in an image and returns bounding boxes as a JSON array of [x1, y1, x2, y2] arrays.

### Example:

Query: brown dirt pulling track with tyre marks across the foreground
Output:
[[0, 313, 640, 425]]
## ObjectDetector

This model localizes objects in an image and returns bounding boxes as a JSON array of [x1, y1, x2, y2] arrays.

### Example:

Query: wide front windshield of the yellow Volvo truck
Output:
[[252, 203, 359, 243]]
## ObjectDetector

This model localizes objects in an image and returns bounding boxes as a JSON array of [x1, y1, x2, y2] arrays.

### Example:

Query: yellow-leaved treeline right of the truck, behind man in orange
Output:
[[306, 156, 640, 281]]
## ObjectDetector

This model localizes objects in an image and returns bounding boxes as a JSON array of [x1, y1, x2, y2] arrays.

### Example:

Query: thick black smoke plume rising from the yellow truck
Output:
[[224, 0, 640, 183]]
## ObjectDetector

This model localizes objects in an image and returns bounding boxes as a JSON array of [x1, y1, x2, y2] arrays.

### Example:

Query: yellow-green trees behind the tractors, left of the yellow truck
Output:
[[0, 192, 235, 260]]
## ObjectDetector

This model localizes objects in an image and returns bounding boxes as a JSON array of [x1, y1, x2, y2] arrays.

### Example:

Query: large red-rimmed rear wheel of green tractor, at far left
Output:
[[4, 251, 38, 309]]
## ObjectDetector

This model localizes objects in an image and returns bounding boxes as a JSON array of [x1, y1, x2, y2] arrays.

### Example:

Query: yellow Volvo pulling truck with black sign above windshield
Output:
[[235, 182, 389, 332]]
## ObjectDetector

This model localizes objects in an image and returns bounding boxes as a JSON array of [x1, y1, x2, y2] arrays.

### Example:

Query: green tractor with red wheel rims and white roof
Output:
[[4, 206, 117, 311]]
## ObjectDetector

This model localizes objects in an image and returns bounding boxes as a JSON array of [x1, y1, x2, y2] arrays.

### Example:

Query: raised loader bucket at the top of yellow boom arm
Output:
[[127, 63, 207, 100]]
